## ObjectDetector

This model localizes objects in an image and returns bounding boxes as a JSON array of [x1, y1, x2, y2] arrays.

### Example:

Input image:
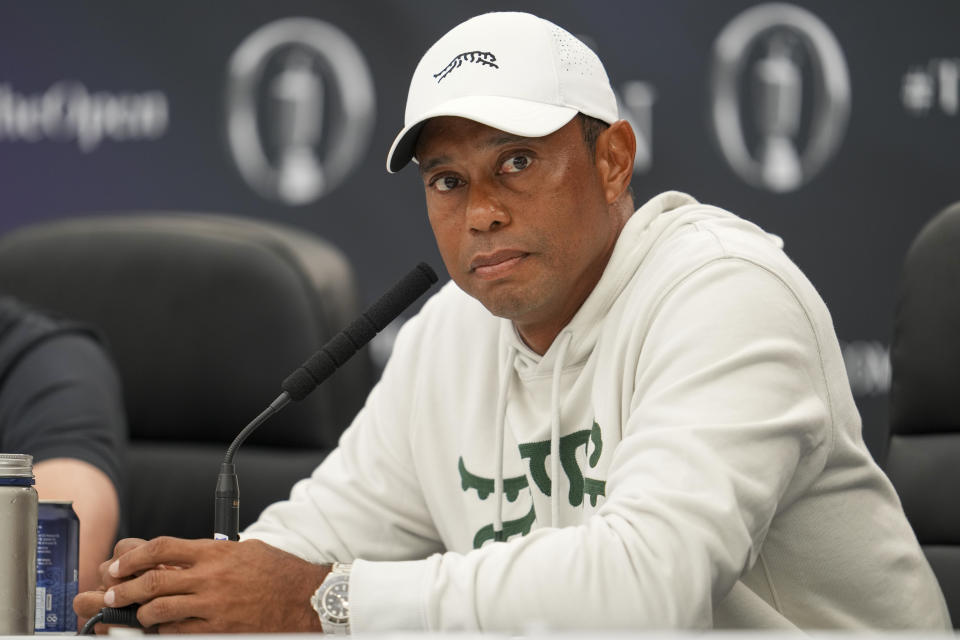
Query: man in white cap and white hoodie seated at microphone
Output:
[[76, 13, 949, 633]]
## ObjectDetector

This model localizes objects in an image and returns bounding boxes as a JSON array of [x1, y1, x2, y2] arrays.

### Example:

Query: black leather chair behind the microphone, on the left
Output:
[[0, 213, 374, 538]]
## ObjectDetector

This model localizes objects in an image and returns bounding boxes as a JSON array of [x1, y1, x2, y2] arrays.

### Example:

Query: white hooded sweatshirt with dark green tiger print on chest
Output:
[[243, 192, 950, 632]]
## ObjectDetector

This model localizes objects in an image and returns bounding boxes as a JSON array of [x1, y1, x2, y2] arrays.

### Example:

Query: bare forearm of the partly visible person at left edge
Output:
[[33, 458, 120, 591]]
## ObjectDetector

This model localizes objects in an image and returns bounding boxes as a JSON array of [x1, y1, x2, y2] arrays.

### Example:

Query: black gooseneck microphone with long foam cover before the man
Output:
[[213, 262, 437, 540]]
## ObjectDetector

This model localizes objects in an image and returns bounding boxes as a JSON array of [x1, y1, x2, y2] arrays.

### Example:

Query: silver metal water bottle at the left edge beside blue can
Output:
[[0, 453, 37, 636]]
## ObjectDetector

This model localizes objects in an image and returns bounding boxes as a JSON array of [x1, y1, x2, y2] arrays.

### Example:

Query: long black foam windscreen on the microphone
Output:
[[281, 262, 437, 400]]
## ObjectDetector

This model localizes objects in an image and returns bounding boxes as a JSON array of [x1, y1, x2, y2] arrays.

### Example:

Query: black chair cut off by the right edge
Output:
[[886, 203, 960, 628]]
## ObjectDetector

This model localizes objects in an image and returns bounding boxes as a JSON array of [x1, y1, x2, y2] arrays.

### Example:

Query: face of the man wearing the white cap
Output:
[[417, 117, 623, 346]]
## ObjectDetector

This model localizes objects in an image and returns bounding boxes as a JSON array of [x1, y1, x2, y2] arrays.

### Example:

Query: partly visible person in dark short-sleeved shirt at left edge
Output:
[[0, 297, 126, 591]]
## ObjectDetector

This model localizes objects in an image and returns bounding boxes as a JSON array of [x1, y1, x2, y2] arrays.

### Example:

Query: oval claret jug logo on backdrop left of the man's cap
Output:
[[226, 18, 375, 205]]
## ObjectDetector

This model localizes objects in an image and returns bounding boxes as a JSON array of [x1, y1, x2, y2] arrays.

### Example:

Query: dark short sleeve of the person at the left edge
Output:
[[0, 332, 126, 492]]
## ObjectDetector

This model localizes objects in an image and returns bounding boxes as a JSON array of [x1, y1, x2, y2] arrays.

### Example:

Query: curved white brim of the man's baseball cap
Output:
[[387, 96, 578, 173]]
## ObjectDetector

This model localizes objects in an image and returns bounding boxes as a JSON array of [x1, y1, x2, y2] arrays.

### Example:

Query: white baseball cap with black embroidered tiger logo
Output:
[[387, 12, 619, 173]]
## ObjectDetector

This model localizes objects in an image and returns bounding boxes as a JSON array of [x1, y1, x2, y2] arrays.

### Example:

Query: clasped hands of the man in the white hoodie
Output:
[[74, 537, 330, 633]]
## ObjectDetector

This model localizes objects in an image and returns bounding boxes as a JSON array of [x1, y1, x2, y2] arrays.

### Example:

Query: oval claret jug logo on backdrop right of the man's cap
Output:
[[711, 3, 850, 193]]
